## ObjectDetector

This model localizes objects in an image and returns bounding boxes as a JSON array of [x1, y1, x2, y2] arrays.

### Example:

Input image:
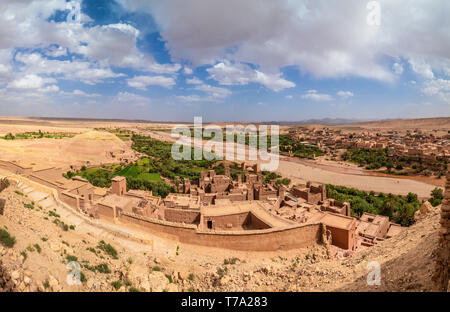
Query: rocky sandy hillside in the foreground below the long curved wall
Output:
[[0, 179, 439, 291]]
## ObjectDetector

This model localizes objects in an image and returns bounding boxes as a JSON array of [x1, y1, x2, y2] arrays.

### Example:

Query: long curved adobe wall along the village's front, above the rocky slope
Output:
[[119, 212, 321, 251]]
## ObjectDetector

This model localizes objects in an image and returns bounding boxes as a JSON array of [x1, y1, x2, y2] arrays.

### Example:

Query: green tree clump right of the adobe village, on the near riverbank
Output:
[[327, 184, 420, 226]]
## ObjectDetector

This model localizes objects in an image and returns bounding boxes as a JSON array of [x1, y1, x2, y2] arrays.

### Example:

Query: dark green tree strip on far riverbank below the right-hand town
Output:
[[342, 148, 448, 177]]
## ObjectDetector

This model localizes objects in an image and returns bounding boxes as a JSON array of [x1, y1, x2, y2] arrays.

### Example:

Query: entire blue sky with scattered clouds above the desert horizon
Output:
[[0, 0, 450, 122]]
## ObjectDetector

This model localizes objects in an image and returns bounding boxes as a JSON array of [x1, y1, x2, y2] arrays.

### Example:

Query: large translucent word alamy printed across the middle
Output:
[[171, 117, 280, 171]]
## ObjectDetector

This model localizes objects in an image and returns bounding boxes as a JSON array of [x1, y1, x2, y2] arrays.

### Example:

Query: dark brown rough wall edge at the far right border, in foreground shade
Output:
[[433, 164, 450, 291]]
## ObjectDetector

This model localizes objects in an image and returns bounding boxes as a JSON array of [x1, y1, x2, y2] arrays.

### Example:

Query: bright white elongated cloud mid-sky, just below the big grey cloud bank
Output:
[[207, 60, 295, 92]]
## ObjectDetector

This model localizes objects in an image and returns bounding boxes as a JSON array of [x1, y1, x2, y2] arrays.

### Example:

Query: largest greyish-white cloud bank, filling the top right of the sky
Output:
[[119, 0, 450, 81]]
